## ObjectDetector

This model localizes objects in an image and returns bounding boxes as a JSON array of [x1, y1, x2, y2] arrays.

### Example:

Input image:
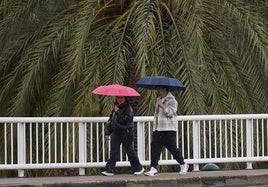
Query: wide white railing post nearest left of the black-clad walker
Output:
[[79, 122, 87, 175]]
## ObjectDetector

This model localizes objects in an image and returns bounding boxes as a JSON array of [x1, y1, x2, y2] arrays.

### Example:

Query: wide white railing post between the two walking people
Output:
[[137, 122, 145, 161]]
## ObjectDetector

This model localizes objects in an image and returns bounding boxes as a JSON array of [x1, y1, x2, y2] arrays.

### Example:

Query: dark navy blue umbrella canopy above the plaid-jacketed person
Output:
[[136, 76, 184, 91]]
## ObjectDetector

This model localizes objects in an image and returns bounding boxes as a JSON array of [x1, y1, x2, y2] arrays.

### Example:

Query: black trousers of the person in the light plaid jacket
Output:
[[151, 131, 185, 168]]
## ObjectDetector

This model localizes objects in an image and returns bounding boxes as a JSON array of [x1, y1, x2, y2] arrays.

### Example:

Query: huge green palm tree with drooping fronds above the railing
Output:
[[0, 0, 268, 175]]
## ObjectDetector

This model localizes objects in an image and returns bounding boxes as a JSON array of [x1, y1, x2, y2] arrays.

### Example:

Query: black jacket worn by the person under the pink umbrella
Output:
[[105, 102, 134, 135]]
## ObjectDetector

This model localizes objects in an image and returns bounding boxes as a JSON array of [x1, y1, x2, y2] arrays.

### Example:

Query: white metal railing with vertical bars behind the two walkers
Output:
[[0, 114, 268, 177]]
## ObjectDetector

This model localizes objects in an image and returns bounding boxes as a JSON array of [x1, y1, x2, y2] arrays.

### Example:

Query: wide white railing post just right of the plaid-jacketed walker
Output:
[[193, 120, 200, 171]]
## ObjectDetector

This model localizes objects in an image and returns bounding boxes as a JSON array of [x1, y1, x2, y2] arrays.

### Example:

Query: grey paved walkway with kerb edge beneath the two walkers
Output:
[[0, 169, 268, 187]]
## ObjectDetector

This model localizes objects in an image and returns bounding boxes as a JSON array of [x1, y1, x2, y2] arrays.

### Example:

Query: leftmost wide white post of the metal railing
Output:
[[17, 123, 26, 177]]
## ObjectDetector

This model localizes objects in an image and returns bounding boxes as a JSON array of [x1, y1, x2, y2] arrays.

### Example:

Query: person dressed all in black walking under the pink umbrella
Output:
[[101, 96, 144, 176]]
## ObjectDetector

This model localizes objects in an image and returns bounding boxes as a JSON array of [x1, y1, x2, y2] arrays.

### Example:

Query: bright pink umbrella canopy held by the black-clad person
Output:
[[92, 84, 140, 97]]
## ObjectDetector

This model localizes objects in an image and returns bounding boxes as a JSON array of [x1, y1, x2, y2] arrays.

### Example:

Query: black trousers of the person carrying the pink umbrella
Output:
[[105, 129, 142, 172]]
